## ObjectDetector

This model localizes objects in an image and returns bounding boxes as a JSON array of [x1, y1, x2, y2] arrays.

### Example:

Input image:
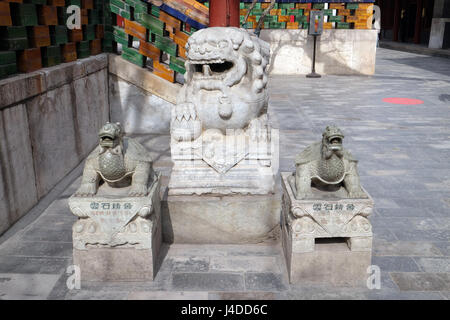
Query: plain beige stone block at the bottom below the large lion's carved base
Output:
[[162, 190, 281, 244]]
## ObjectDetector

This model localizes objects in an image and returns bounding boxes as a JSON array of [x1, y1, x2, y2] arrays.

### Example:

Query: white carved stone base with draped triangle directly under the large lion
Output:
[[169, 127, 278, 195]]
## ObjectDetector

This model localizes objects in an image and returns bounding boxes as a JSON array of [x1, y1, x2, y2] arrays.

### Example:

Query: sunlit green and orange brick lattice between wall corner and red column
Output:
[[105, 0, 208, 82]]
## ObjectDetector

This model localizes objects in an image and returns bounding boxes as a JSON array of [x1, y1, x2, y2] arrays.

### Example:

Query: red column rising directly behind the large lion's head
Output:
[[209, 0, 239, 27]]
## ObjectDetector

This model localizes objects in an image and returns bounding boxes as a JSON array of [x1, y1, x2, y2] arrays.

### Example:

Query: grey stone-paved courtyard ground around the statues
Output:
[[0, 49, 450, 299]]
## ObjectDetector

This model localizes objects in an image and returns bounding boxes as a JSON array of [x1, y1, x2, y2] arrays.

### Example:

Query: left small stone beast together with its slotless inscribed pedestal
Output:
[[69, 124, 162, 281]]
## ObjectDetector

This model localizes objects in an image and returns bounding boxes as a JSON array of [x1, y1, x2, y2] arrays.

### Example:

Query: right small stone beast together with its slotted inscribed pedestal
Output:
[[281, 127, 374, 286]]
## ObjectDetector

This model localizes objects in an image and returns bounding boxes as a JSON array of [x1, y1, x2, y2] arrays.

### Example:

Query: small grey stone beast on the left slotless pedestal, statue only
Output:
[[75, 122, 152, 197]]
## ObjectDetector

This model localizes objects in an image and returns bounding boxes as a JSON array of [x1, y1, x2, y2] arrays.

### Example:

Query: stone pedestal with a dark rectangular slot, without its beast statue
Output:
[[281, 173, 373, 286]]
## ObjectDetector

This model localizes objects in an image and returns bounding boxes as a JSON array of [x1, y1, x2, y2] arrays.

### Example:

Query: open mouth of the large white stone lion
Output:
[[190, 59, 234, 80]]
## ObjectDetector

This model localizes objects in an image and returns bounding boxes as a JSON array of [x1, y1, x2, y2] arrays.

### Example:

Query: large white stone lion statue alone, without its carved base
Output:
[[171, 27, 270, 141]]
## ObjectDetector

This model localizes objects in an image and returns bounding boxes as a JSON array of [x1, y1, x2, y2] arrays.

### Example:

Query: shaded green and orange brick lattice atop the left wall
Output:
[[0, 0, 111, 78]]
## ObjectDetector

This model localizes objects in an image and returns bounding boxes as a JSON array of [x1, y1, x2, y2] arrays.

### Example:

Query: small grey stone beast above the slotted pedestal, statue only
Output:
[[295, 126, 366, 199]]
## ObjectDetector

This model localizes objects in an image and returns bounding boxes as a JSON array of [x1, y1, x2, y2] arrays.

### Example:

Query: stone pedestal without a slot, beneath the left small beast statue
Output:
[[69, 175, 162, 281]]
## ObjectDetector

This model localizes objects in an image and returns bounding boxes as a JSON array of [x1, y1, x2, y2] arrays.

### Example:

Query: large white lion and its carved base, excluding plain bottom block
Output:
[[169, 27, 277, 195]]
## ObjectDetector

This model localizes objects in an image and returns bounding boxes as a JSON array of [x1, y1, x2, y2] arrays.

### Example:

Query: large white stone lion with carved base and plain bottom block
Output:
[[163, 27, 279, 243]]
